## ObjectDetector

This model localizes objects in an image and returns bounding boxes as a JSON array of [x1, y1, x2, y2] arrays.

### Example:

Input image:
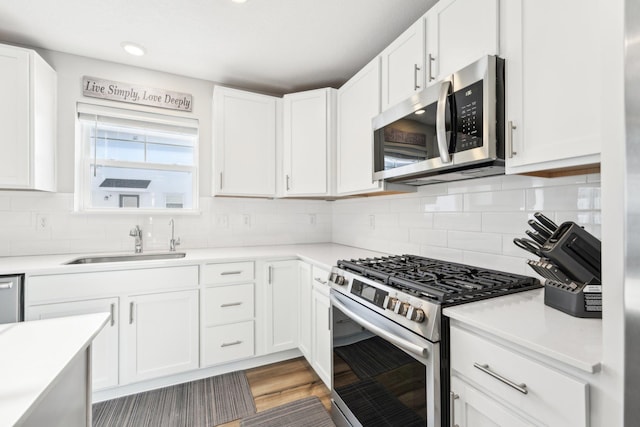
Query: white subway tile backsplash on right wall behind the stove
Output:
[[332, 174, 600, 275]]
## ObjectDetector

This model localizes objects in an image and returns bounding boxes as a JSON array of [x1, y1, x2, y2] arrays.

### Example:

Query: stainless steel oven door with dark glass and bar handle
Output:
[[331, 289, 440, 427]]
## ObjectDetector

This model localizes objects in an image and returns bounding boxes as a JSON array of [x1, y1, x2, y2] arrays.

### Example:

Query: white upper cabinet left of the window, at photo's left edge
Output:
[[0, 45, 57, 191]]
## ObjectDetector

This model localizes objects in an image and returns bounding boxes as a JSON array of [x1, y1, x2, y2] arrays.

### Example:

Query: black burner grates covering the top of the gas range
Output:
[[338, 255, 540, 305]]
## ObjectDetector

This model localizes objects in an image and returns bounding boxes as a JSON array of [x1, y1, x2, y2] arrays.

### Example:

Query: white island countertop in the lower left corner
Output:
[[0, 313, 109, 427]]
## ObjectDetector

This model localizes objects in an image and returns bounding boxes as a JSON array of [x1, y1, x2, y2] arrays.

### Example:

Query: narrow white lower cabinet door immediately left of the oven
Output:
[[312, 285, 331, 388]]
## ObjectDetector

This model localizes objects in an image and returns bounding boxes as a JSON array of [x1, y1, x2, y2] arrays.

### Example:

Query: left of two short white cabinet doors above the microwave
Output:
[[380, 18, 425, 110]]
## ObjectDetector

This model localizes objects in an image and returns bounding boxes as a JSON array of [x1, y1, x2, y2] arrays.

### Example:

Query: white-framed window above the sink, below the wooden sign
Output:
[[76, 103, 198, 211]]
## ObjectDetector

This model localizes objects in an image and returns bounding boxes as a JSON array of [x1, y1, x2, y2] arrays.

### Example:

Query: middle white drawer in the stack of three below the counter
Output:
[[204, 283, 253, 325]]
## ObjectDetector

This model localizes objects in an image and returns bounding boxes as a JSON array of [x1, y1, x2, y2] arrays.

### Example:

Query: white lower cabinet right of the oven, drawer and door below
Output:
[[451, 325, 589, 427]]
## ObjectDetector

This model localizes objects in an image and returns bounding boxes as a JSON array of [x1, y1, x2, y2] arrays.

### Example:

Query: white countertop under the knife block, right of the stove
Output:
[[444, 289, 602, 373]]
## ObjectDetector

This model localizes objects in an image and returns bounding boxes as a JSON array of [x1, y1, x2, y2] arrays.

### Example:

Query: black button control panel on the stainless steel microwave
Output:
[[454, 80, 483, 152]]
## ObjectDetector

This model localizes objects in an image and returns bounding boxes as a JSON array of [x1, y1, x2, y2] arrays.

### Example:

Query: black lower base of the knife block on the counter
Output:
[[544, 279, 602, 319]]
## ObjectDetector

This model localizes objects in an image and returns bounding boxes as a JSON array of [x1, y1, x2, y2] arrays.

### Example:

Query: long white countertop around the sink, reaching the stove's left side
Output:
[[0, 243, 387, 275]]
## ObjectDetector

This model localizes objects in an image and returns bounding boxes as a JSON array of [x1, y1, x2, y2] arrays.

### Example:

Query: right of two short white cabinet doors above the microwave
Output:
[[426, 0, 500, 84]]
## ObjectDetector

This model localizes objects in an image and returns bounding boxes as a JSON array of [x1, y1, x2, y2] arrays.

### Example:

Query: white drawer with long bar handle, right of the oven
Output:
[[451, 326, 589, 427]]
